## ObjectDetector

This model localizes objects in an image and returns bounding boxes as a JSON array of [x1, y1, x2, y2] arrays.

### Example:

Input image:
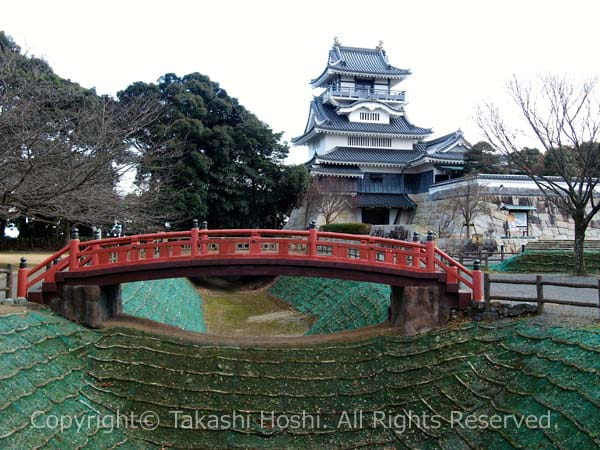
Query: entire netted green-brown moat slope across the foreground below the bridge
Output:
[[0, 312, 600, 449]]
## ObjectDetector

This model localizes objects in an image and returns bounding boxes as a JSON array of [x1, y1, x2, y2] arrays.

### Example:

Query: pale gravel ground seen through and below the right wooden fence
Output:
[[490, 273, 600, 326]]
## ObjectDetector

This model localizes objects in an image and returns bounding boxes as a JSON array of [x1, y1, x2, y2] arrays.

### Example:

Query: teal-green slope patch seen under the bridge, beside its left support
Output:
[[121, 278, 206, 333]]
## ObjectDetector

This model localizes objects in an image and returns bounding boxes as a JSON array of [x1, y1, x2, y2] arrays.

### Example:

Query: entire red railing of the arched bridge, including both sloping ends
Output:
[[18, 226, 481, 300]]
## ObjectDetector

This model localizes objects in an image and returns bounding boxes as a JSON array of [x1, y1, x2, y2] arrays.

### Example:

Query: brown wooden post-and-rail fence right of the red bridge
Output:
[[483, 273, 600, 314]]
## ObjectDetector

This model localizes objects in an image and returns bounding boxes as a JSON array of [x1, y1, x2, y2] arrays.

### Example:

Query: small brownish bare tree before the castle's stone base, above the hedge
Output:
[[305, 177, 358, 224]]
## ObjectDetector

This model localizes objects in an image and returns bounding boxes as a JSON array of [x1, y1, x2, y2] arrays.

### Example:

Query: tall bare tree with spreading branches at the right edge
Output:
[[477, 75, 600, 275]]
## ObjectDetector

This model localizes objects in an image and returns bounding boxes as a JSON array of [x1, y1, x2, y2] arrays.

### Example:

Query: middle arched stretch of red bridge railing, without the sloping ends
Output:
[[69, 230, 427, 271]]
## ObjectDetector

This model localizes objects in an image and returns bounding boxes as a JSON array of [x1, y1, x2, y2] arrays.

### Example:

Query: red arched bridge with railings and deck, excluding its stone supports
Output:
[[18, 226, 482, 332]]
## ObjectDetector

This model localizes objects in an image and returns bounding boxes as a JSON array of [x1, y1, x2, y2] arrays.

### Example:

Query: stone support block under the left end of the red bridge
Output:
[[50, 285, 122, 328]]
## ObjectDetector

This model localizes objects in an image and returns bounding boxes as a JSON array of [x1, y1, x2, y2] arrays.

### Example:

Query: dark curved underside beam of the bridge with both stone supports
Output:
[[53, 257, 460, 334]]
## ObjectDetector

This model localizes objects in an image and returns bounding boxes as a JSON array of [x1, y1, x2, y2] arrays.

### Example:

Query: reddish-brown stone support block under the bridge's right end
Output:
[[390, 286, 450, 336]]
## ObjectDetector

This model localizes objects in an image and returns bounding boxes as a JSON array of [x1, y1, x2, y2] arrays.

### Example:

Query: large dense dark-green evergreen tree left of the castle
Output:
[[118, 73, 308, 228]]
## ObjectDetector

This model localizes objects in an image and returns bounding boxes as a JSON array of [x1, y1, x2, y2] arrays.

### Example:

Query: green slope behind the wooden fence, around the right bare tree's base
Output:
[[490, 250, 600, 273]]
